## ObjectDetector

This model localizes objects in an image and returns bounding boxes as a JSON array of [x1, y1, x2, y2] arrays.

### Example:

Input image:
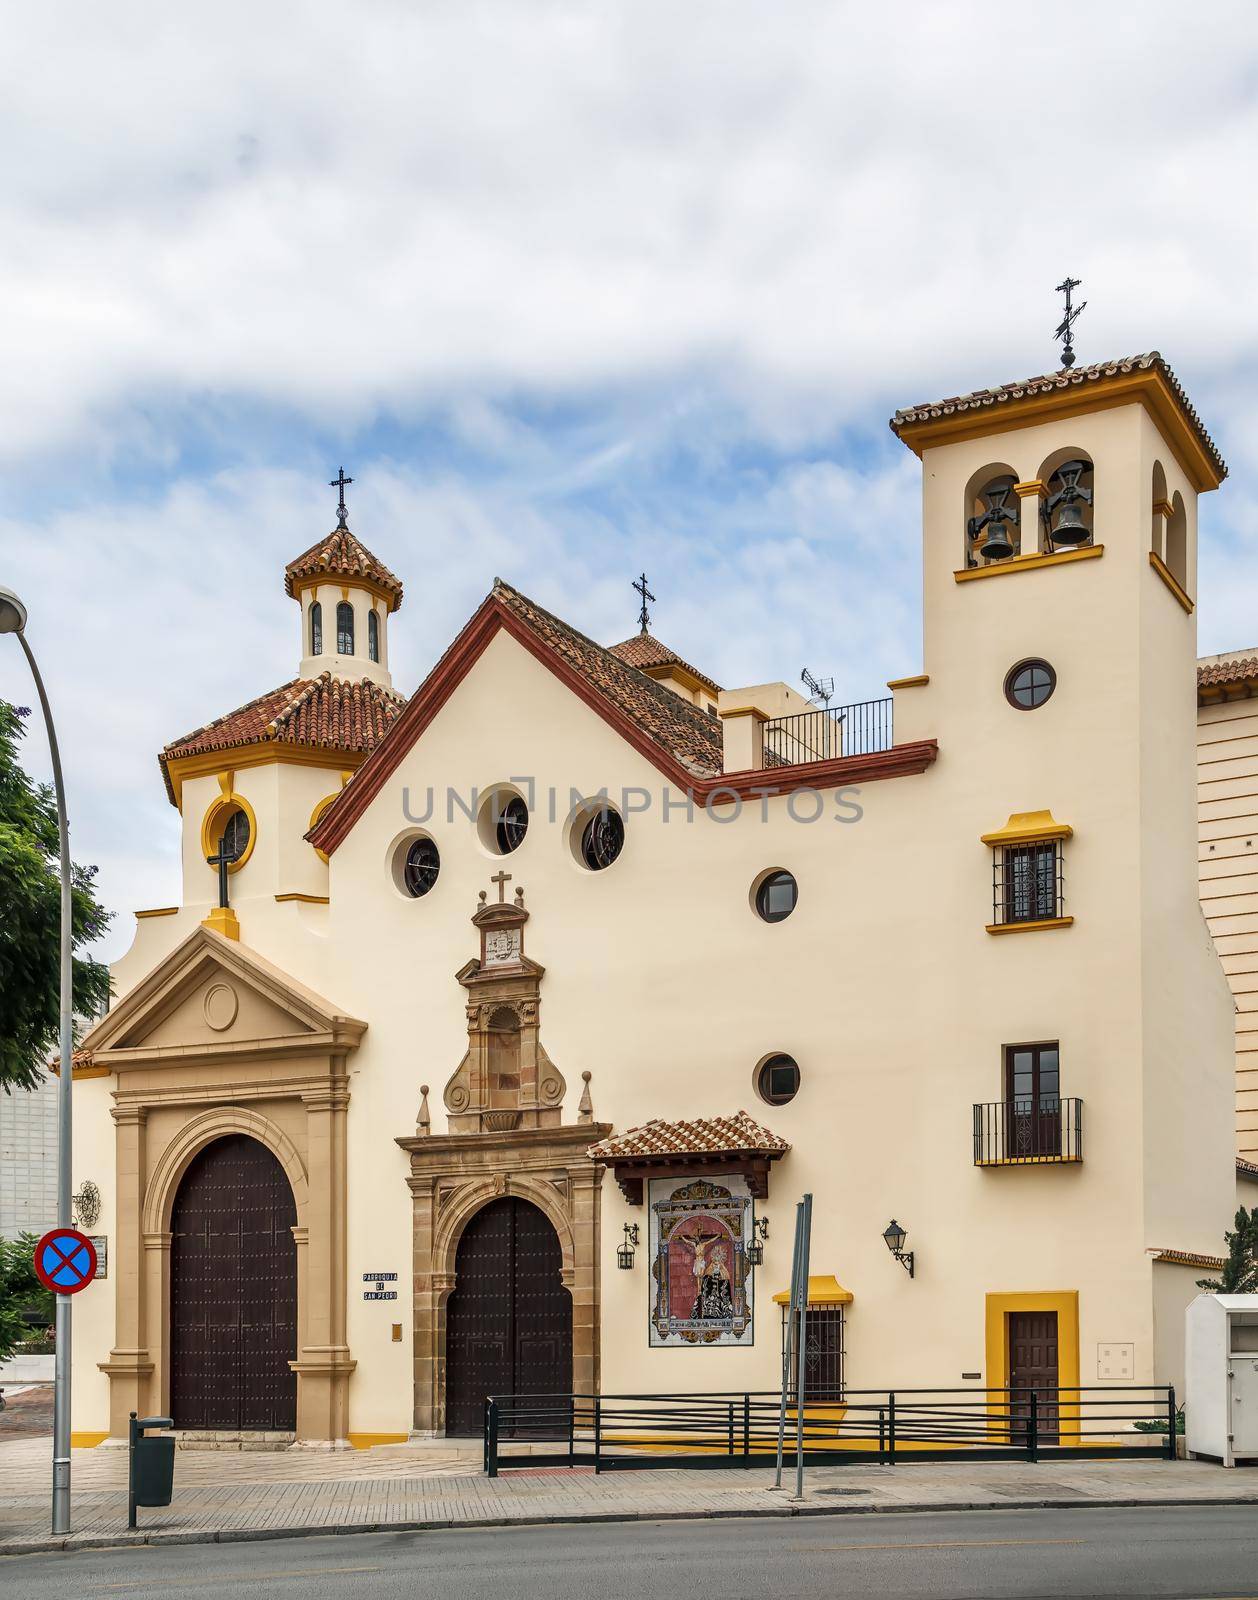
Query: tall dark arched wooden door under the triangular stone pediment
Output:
[[170, 1134, 298, 1432]]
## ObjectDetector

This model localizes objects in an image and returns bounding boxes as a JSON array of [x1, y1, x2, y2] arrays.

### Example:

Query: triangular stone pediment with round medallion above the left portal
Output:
[[83, 926, 367, 1072]]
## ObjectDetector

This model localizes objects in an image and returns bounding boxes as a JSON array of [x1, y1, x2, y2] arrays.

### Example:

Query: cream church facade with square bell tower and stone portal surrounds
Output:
[[66, 353, 1236, 1443]]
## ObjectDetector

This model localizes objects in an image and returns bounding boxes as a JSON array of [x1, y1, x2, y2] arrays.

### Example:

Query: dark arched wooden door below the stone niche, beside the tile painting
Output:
[[445, 1197, 573, 1435]]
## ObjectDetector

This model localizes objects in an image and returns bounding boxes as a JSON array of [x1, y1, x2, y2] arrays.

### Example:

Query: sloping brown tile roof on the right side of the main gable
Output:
[[493, 578, 722, 778]]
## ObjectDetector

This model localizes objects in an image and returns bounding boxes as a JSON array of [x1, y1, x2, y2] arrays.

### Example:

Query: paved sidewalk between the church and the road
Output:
[[0, 1438, 1258, 1555]]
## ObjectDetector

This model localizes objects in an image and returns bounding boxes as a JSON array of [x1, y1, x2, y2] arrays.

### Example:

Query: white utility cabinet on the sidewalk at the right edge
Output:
[[1184, 1294, 1258, 1467]]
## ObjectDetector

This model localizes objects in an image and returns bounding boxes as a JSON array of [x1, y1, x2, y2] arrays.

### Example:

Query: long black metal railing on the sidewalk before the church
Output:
[[485, 1384, 1176, 1477]]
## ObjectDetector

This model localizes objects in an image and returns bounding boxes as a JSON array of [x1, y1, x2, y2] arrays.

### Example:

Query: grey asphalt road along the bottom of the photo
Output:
[[0, 1506, 1258, 1600]]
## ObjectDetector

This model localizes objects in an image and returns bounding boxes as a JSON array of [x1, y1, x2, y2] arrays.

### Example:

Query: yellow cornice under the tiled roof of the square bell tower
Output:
[[896, 368, 1223, 493]]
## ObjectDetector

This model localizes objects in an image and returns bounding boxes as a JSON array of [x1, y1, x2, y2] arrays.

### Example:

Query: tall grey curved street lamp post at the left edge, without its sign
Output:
[[0, 587, 74, 1533]]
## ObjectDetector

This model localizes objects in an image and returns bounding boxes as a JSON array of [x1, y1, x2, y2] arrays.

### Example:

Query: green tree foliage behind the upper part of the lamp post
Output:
[[0, 701, 109, 1090]]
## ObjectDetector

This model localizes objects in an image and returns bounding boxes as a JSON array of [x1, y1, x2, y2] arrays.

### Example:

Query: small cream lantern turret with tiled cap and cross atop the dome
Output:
[[285, 467, 402, 688]]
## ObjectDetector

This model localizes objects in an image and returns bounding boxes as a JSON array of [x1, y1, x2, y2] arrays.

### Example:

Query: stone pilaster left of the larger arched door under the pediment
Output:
[[101, 1102, 152, 1438]]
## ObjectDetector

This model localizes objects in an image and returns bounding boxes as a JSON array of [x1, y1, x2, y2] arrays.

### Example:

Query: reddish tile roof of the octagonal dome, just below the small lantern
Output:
[[158, 672, 407, 798]]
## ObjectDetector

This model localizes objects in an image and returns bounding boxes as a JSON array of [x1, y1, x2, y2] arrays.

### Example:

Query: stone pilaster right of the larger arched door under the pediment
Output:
[[291, 1078, 357, 1450]]
